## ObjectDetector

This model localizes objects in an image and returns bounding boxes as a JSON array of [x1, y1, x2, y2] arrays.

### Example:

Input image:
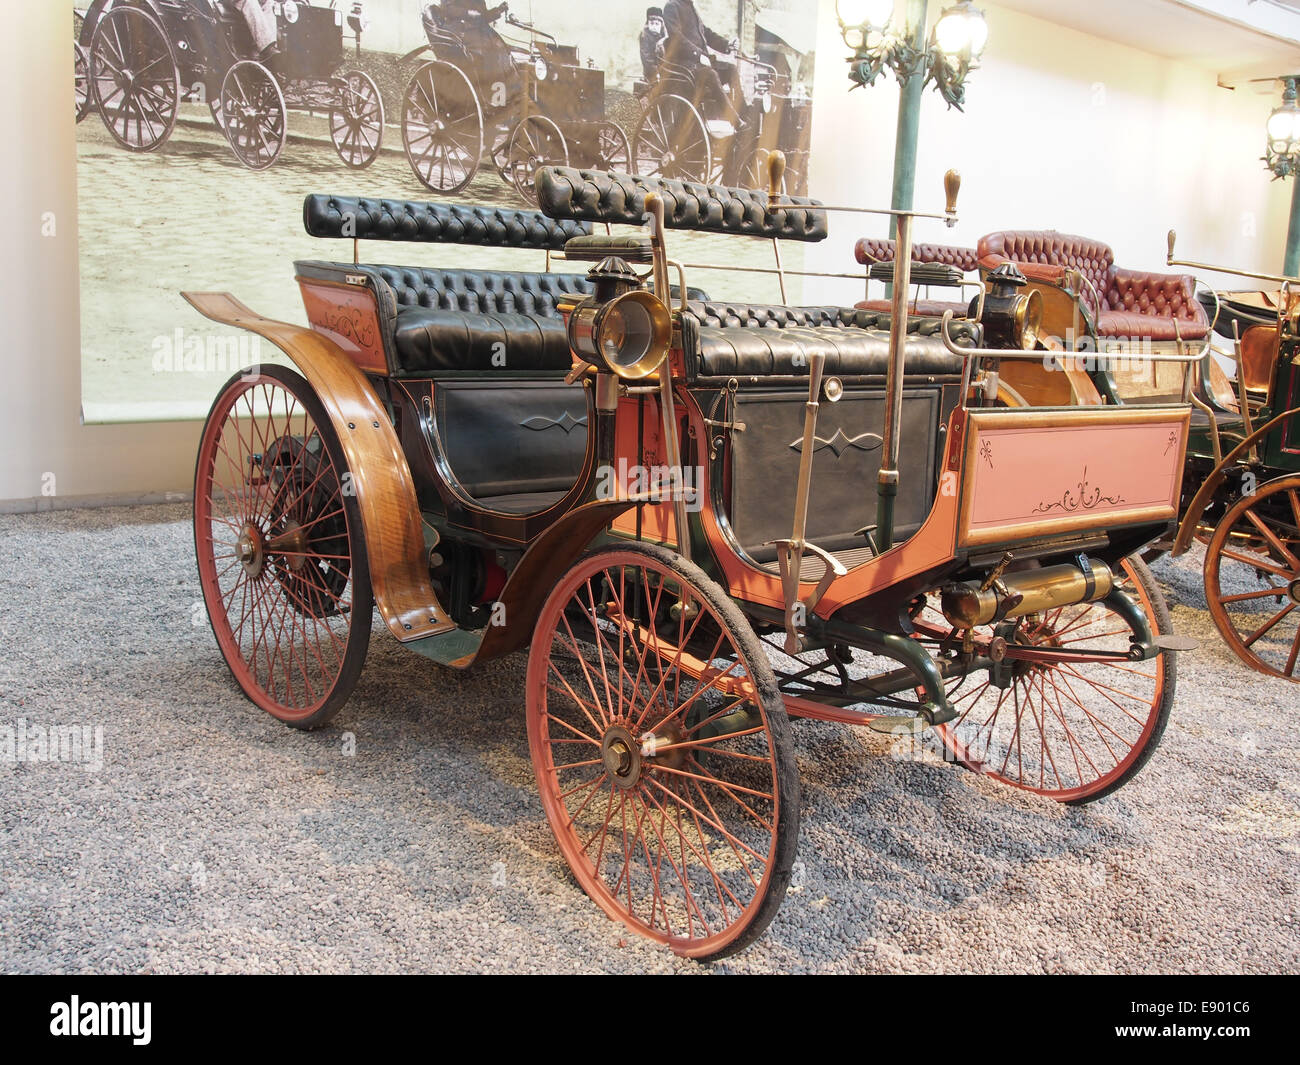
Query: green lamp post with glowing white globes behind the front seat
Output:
[[835, 0, 988, 237]]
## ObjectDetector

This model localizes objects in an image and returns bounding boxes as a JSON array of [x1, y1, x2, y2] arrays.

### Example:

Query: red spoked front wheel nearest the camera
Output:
[[528, 544, 800, 958]]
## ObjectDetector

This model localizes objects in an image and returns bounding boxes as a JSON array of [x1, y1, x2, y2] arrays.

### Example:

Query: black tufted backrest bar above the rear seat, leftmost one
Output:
[[303, 192, 592, 251]]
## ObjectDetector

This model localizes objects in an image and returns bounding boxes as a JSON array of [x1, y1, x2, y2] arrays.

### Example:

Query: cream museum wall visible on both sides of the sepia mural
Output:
[[12, 0, 1291, 508]]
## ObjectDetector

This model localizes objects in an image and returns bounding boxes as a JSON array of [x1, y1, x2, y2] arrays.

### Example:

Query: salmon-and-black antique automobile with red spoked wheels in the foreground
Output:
[[186, 160, 1190, 958]]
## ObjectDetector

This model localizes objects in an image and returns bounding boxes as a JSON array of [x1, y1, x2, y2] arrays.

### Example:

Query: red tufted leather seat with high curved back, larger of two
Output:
[[978, 230, 1210, 341]]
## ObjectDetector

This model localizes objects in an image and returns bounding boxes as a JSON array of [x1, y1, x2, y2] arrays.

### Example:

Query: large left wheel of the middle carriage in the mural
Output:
[[402, 60, 484, 194]]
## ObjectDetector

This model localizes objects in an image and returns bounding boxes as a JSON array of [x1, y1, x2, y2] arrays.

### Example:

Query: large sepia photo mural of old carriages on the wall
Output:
[[73, 0, 816, 421]]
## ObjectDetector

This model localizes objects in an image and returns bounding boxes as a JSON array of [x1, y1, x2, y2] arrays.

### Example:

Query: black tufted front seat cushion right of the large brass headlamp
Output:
[[683, 300, 976, 377]]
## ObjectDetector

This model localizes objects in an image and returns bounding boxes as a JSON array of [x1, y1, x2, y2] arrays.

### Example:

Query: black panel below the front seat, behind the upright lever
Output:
[[729, 388, 941, 562]]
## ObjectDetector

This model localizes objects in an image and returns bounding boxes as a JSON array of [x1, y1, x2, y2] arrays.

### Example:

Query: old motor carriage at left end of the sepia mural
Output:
[[77, 0, 384, 170]]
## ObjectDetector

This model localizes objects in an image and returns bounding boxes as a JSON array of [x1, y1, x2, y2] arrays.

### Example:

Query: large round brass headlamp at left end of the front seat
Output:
[[568, 255, 672, 380]]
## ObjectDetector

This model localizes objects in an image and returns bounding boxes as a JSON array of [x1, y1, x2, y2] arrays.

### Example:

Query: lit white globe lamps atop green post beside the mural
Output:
[[835, 0, 988, 111]]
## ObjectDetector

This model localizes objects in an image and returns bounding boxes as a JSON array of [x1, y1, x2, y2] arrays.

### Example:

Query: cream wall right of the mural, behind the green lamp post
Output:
[[805, 0, 1291, 308]]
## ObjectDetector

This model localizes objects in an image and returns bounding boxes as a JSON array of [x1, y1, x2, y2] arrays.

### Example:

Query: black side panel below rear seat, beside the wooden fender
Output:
[[436, 381, 586, 499]]
